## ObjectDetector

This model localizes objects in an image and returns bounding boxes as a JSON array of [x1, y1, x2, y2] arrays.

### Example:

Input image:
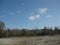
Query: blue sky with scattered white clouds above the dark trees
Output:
[[0, 0, 60, 29]]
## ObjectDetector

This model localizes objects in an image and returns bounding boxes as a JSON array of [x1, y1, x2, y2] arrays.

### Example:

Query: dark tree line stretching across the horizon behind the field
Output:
[[0, 21, 60, 38]]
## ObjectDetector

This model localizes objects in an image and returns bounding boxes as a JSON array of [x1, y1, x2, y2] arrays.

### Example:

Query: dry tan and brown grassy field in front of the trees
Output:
[[0, 36, 60, 45]]
